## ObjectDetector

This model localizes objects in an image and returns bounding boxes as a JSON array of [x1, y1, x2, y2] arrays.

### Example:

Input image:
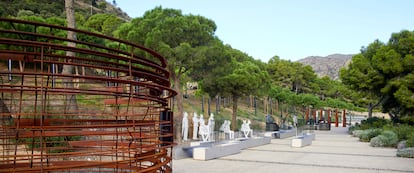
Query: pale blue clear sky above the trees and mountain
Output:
[[108, 0, 414, 62]]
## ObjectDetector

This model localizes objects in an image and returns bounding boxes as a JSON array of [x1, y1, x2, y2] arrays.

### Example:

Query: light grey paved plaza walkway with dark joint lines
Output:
[[173, 127, 414, 173]]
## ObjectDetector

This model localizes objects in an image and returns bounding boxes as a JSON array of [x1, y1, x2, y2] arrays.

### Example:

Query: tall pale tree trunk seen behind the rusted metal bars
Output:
[[62, 0, 78, 112]]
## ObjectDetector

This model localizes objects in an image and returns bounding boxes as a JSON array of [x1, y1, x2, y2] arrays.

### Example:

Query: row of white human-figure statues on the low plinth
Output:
[[181, 112, 253, 142]]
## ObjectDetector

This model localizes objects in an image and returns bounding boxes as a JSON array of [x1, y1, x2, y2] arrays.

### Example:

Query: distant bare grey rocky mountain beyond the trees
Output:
[[298, 54, 353, 80]]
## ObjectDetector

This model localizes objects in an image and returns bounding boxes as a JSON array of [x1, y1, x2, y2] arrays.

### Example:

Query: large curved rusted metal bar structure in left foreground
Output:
[[0, 18, 176, 172]]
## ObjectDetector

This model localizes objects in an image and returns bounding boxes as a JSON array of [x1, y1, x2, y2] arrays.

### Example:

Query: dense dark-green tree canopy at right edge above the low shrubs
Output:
[[340, 30, 414, 120]]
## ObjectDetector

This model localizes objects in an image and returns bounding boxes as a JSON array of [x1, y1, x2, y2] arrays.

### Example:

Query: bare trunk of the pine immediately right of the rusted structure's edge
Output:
[[171, 72, 184, 142]]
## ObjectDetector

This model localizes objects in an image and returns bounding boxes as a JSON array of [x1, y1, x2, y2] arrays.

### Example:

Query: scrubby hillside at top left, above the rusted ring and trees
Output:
[[0, 0, 131, 21]]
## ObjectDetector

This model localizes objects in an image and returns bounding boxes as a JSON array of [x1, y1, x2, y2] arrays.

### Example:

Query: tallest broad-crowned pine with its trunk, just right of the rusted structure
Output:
[[114, 7, 216, 139]]
